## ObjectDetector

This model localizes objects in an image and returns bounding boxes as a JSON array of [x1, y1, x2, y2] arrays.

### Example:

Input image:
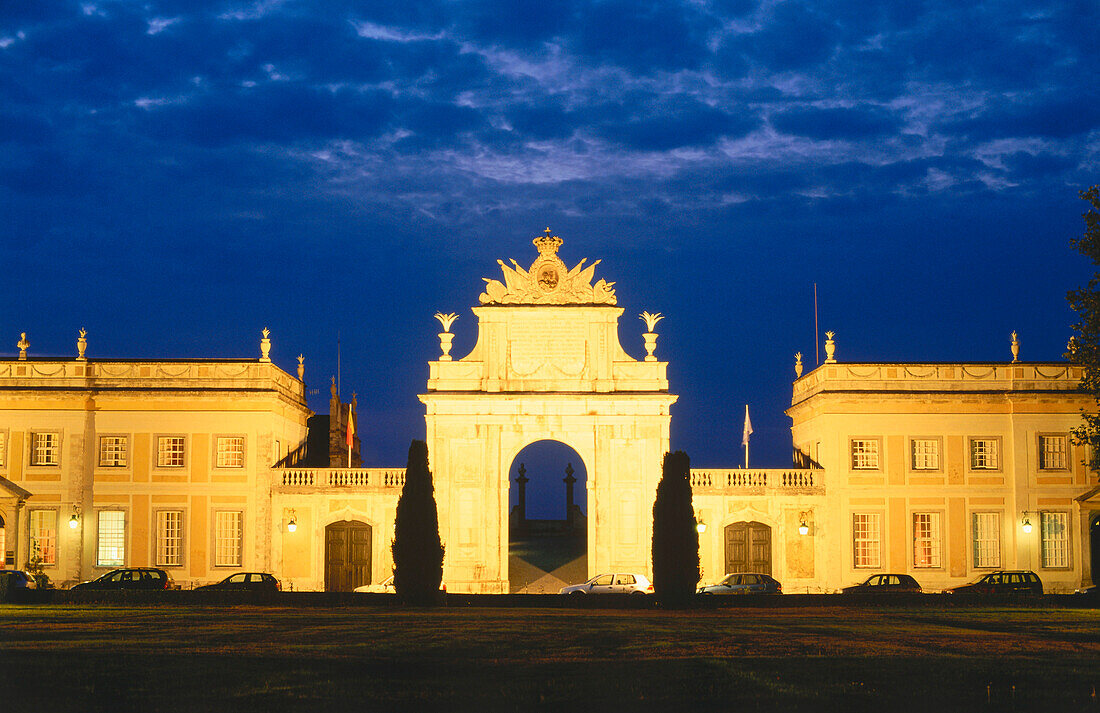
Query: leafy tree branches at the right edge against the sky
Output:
[[1066, 186, 1100, 473]]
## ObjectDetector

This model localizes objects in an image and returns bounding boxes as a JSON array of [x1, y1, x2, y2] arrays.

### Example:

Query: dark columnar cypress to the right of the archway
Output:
[[653, 451, 699, 606]]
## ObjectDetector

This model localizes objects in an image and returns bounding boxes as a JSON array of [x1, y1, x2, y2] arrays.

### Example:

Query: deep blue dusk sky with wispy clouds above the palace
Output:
[[0, 0, 1100, 492]]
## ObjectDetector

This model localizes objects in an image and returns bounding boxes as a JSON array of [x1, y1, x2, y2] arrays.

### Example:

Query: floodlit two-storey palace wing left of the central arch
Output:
[[0, 347, 309, 585]]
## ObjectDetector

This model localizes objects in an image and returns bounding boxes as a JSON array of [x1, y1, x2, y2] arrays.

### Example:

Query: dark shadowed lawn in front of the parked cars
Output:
[[0, 605, 1100, 712]]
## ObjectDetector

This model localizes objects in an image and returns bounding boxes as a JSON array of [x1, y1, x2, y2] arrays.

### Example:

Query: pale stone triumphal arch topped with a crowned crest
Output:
[[420, 229, 677, 593]]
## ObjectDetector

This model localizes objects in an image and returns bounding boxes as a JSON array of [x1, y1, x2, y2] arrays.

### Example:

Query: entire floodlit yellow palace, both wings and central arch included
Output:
[[0, 231, 1100, 593]]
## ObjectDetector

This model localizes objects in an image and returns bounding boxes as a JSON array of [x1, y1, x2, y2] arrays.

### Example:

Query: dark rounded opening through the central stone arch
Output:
[[508, 440, 589, 594]]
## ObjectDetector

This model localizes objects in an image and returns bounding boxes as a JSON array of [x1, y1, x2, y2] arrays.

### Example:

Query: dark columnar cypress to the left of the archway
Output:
[[392, 440, 443, 605]]
